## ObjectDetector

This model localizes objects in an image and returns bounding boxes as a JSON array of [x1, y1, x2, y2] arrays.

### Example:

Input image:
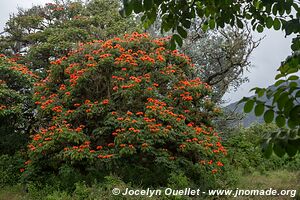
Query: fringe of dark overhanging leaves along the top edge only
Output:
[[121, 0, 300, 46]]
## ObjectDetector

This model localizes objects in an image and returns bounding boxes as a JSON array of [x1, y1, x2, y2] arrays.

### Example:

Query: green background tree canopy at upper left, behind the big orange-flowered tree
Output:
[[0, 0, 137, 71]]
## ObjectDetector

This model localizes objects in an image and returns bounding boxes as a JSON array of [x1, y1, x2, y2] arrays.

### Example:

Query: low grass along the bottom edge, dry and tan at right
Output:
[[0, 170, 300, 200]]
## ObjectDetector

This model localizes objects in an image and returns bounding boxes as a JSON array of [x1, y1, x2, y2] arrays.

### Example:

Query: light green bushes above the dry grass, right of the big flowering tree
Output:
[[224, 124, 300, 173]]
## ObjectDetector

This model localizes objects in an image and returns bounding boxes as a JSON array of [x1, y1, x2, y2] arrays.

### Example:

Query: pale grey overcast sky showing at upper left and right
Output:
[[0, 0, 291, 102]]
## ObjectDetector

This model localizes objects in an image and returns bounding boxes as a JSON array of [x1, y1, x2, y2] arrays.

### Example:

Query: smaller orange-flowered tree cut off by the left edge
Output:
[[0, 55, 36, 154]]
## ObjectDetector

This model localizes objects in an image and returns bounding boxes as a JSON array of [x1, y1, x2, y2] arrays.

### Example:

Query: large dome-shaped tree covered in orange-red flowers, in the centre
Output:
[[27, 33, 226, 184]]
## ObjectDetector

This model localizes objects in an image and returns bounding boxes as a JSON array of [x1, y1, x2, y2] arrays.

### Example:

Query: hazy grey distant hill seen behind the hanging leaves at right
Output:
[[225, 80, 300, 127]]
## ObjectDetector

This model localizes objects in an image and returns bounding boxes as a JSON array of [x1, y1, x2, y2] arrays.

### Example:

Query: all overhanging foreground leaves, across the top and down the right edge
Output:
[[120, 0, 300, 156]]
